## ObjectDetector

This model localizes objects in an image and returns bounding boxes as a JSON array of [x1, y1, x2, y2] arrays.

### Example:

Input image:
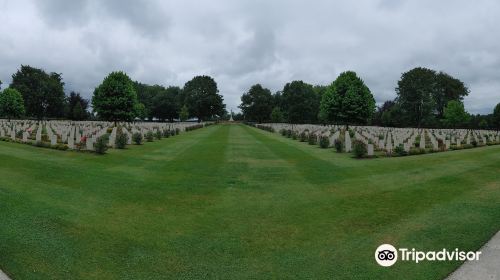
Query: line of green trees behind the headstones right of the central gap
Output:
[[239, 67, 500, 129]]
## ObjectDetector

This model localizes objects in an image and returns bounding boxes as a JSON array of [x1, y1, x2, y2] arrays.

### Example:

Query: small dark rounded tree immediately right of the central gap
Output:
[[239, 84, 273, 123]]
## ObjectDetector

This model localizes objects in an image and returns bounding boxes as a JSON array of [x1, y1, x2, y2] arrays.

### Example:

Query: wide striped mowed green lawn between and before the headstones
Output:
[[0, 125, 500, 279]]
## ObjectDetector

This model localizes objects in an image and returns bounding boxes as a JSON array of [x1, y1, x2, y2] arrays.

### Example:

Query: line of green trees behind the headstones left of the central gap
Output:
[[0, 65, 227, 121]]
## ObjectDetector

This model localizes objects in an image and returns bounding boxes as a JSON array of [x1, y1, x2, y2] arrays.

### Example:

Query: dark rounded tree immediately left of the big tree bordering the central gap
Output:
[[151, 87, 182, 121]]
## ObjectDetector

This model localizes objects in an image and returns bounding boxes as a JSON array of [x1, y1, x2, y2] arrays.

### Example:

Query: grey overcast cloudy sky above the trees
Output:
[[0, 0, 500, 113]]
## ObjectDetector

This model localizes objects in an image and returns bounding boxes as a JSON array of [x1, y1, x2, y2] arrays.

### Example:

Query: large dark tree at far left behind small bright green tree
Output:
[[10, 65, 65, 119]]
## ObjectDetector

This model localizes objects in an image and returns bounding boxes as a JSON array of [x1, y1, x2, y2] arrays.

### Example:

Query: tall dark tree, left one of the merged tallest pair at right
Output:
[[396, 67, 437, 127]]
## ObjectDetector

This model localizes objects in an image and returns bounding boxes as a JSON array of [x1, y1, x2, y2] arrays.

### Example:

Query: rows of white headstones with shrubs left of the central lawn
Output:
[[0, 119, 211, 151]]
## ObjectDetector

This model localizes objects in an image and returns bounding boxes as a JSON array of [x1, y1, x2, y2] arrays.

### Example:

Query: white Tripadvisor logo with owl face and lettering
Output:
[[375, 244, 481, 267]]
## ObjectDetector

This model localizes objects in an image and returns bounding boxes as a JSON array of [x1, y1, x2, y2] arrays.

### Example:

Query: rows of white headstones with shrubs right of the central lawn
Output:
[[256, 123, 500, 157]]
